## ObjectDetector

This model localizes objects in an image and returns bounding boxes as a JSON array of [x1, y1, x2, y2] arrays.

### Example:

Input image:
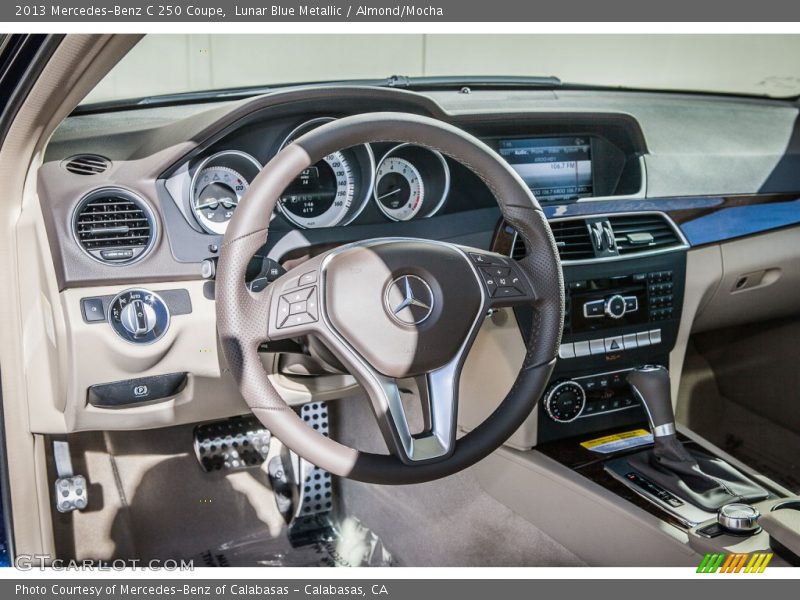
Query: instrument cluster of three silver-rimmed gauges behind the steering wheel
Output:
[[189, 117, 450, 235]]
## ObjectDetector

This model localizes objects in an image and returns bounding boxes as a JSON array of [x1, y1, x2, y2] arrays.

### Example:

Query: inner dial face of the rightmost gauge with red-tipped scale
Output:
[[375, 156, 425, 221]]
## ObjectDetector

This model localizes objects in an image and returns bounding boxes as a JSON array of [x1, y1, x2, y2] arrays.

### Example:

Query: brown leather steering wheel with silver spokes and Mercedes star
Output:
[[216, 113, 564, 484]]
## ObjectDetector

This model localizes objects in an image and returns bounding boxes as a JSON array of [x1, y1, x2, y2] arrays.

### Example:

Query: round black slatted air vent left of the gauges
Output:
[[73, 188, 156, 265]]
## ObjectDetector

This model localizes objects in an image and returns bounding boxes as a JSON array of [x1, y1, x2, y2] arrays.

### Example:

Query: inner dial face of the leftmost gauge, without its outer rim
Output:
[[192, 167, 248, 233]]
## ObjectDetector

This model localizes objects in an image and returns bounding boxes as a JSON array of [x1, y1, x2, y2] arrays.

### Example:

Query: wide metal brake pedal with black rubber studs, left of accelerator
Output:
[[194, 416, 272, 473]]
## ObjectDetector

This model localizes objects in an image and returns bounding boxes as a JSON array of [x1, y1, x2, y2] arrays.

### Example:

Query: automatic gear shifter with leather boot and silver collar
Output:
[[628, 365, 768, 511]]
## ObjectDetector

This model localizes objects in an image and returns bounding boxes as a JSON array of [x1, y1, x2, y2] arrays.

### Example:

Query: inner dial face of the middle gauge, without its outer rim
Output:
[[278, 152, 356, 228]]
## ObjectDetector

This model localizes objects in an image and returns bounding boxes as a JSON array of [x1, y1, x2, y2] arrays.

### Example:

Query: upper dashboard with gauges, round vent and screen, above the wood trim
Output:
[[39, 87, 800, 287]]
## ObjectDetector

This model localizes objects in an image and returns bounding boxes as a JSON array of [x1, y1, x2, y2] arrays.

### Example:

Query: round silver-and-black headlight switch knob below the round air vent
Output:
[[108, 289, 170, 344]]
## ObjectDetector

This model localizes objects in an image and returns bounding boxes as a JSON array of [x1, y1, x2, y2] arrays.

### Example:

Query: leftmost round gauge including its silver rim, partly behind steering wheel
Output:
[[191, 150, 261, 235]]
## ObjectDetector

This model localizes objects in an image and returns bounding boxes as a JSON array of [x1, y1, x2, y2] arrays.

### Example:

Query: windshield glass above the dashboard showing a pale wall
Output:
[[84, 34, 800, 103]]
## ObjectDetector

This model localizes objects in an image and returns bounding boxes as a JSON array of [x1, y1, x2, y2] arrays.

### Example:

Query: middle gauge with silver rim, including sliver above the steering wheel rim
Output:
[[278, 117, 375, 228]]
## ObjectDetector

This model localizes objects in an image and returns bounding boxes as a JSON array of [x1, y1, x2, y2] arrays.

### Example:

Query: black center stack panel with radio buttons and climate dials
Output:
[[536, 246, 686, 443]]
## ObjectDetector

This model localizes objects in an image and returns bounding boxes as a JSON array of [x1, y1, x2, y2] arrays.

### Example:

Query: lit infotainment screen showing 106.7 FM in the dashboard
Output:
[[498, 137, 592, 202]]
